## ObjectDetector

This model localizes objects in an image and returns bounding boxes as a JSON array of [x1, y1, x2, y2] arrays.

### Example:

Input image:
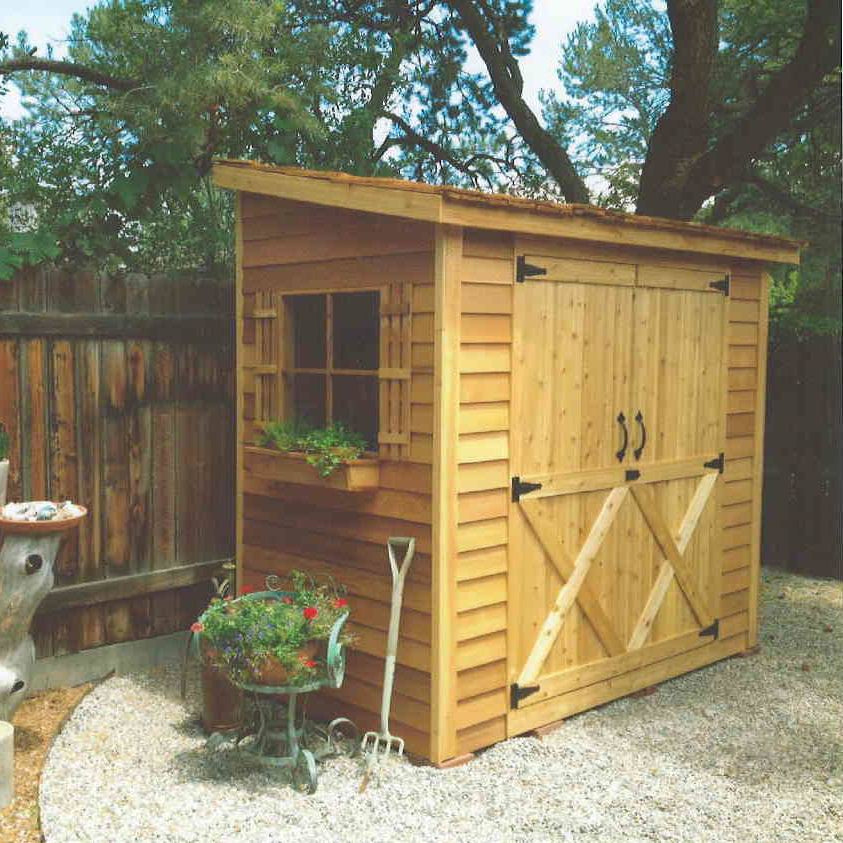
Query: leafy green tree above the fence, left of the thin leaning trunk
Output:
[[0, 0, 539, 274]]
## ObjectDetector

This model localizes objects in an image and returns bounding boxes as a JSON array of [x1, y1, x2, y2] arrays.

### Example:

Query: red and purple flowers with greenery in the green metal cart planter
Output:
[[192, 571, 351, 686]]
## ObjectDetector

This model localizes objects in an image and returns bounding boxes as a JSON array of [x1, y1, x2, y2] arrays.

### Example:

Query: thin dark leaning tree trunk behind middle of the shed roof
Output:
[[450, 0, 589, 203]]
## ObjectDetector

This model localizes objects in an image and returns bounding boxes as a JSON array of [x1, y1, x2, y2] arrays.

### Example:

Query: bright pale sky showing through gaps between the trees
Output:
[[0, 0, 595, 118]]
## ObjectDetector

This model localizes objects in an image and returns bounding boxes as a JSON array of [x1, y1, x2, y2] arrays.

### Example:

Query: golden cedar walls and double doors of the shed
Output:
[[223, 186, 780, 762]]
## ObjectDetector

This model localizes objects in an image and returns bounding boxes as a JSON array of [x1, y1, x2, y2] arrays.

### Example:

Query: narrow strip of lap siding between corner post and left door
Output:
[[455, 231, 514, 753]]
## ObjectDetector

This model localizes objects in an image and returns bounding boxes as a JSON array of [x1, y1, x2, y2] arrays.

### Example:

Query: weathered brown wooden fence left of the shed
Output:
[[0, 269, 234, 656]]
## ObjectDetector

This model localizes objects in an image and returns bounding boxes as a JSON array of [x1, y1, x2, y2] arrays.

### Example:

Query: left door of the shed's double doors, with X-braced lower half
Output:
[[509, 257, 635, 720]]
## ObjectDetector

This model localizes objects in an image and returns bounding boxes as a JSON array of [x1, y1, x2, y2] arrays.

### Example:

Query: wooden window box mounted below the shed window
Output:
[[243, 445, 380, 492]]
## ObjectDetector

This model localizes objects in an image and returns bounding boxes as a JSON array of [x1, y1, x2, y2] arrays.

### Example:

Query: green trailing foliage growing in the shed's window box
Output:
[[258, 421, 366, 477]]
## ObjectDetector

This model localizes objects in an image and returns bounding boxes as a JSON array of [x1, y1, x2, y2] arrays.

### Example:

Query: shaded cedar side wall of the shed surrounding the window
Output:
[[237, 194, 435, 755]]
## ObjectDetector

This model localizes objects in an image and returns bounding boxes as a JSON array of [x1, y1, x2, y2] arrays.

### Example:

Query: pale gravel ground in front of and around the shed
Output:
[[41, 572, 843, 843]]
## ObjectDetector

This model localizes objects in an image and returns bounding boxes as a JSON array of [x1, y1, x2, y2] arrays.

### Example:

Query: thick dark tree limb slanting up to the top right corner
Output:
[[689, 0, 841, 204]]
